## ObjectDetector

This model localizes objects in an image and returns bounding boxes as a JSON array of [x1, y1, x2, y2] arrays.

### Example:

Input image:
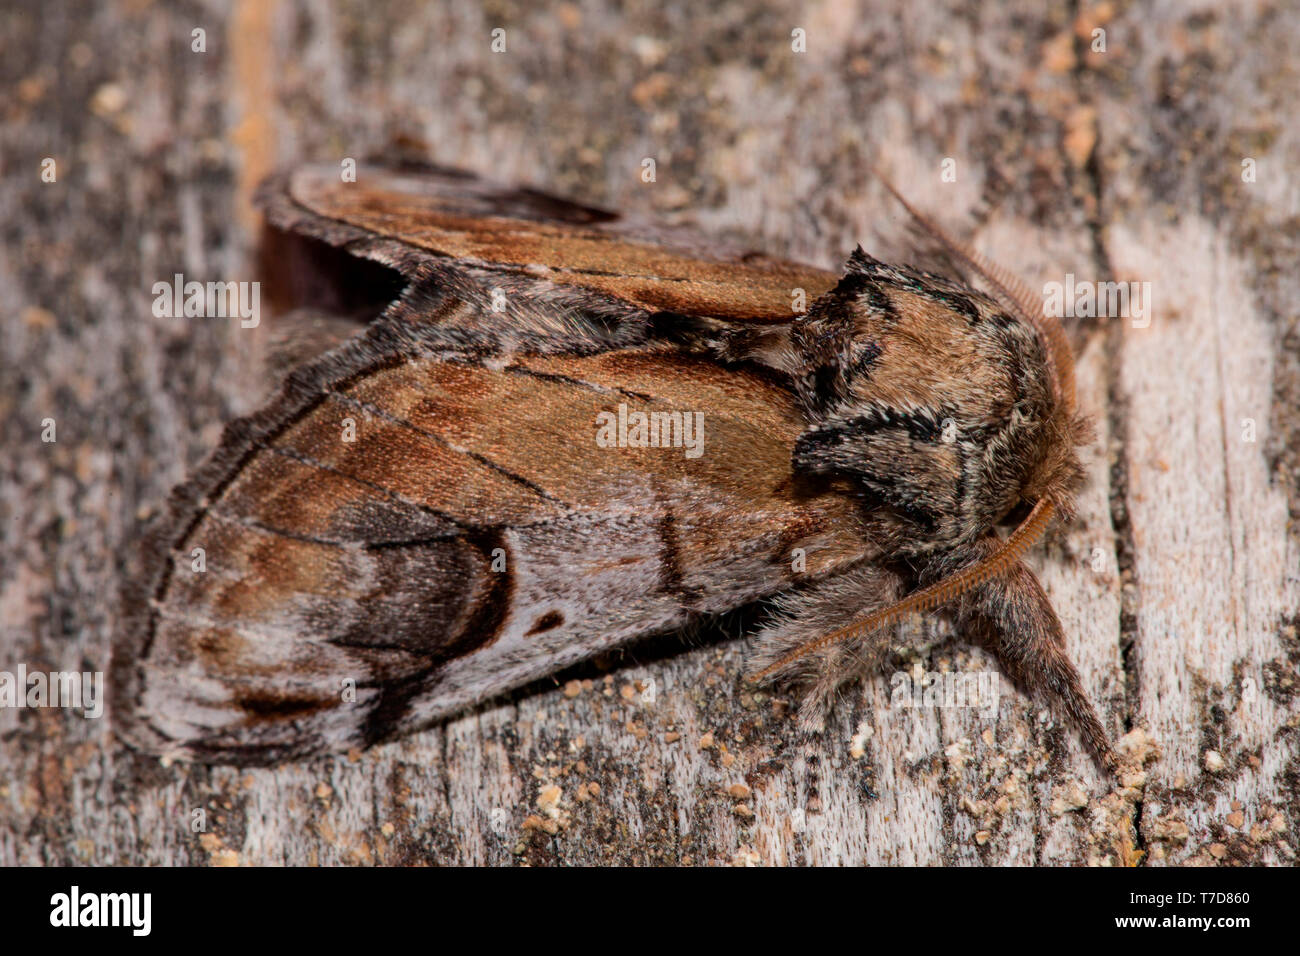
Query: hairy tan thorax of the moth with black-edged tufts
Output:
[[769, 250, 1087, 554]]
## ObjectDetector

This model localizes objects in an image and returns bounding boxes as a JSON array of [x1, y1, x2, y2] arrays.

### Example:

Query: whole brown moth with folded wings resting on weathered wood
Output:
[[113, 158, 1114, 767]]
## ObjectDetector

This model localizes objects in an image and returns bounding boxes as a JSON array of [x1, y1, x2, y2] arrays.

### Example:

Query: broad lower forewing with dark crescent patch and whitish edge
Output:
[[118, 297, 871, 763]]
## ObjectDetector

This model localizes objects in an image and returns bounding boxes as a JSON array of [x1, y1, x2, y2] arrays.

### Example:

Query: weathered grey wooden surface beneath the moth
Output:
[[0, 0, 1300, 865]]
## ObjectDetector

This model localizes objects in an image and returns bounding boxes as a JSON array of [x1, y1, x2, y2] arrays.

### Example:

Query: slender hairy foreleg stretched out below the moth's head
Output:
[[957, 546, 1117, 773]]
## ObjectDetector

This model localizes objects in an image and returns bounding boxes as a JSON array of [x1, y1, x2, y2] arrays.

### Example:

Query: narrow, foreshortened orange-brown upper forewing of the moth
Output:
[[263, 166, 836, 323]]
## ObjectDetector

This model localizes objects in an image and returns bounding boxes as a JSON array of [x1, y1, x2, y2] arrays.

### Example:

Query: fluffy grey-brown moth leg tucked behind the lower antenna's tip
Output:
[[749, 564, 904, 732]]
